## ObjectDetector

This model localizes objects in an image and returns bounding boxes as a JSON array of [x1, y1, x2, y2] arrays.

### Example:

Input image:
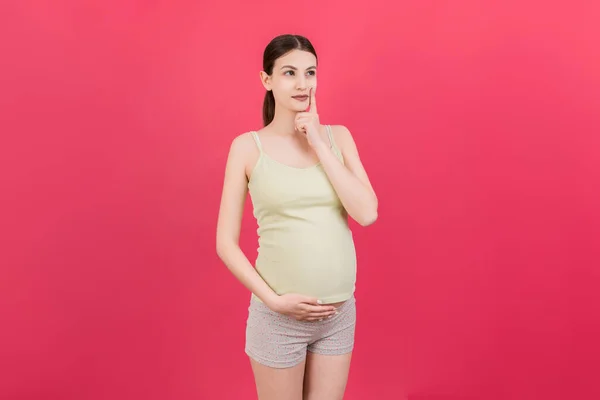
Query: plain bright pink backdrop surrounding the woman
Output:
[[0, 0, 600, 400]]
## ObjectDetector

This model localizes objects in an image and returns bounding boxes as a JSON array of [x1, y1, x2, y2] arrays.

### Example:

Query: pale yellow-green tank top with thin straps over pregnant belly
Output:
[[248, 125, 356, 304]]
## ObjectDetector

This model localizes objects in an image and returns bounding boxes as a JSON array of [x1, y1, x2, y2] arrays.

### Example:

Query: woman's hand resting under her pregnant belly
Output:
[[268, 293, 336, 321]]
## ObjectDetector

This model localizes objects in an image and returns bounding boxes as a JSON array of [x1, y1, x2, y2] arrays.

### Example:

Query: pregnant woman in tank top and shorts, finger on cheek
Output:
[[217, 35, 378, 400]]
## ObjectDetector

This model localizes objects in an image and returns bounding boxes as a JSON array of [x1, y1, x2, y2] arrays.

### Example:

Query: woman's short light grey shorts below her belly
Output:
[[245, 296, 356, 368]]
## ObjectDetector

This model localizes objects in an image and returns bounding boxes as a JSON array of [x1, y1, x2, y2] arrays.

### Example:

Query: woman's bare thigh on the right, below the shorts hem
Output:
[[303, 351, 352, 400]]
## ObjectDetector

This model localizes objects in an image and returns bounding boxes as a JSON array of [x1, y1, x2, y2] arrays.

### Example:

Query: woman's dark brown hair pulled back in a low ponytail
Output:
[[263, 35, 317, 126]]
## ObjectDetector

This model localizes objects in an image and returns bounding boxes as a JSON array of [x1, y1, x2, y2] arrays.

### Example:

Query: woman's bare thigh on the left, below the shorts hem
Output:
[[250, 358, 306, 400]]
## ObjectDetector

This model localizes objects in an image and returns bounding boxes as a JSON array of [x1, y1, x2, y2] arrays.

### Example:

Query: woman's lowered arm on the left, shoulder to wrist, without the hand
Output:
[[217, 135, 278, 308]]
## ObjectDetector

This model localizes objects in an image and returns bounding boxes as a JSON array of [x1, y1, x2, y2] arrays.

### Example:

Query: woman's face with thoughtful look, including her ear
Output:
[[261, 50, 317, 112]]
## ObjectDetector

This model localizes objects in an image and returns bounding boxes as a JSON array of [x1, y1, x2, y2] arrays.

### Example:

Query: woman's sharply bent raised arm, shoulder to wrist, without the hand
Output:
[[314, 125, 378, 226]]
